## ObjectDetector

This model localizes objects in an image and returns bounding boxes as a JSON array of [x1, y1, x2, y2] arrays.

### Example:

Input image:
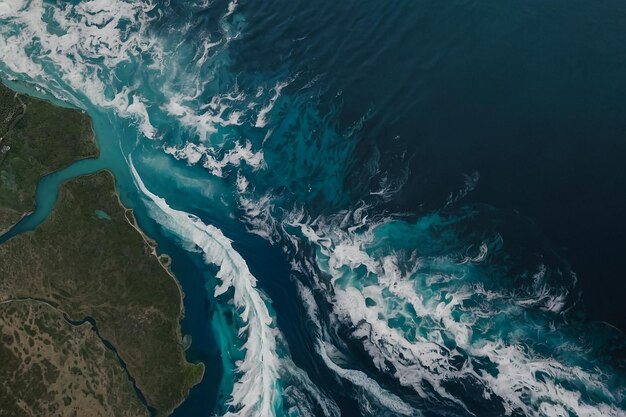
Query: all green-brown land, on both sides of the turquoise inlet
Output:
[[0, 82, 204, 417]]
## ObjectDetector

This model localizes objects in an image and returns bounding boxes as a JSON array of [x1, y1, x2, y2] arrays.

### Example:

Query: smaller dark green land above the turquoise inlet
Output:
[[0, 83, 98, 233]]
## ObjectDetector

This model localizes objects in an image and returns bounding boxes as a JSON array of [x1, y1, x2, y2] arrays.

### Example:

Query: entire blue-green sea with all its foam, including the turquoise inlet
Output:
[[0, 0, 626, 417]]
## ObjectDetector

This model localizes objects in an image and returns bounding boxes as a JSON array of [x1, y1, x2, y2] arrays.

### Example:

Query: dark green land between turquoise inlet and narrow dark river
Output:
[[0, 171, 203, 414]]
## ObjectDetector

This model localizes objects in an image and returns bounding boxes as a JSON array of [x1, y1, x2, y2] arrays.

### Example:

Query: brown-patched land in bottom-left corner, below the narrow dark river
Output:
[[0, 300, 148, 417]]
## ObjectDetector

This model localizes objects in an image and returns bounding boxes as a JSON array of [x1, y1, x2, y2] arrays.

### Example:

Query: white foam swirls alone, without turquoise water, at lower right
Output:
[[290, 212, 625, 417]]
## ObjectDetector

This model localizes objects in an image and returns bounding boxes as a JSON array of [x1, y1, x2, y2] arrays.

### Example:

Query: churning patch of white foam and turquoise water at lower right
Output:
[[276, 208, 626, 416]]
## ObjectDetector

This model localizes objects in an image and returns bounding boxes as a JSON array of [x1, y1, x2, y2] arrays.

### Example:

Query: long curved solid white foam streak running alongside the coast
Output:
[[130, 160, 279, 417]]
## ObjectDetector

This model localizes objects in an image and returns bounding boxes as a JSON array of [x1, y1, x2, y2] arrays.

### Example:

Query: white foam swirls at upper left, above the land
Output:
[[0, 0, 287, 176]]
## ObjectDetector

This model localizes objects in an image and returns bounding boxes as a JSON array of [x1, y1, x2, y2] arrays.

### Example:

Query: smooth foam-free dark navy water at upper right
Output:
[[235, 1, 626, 330]]
